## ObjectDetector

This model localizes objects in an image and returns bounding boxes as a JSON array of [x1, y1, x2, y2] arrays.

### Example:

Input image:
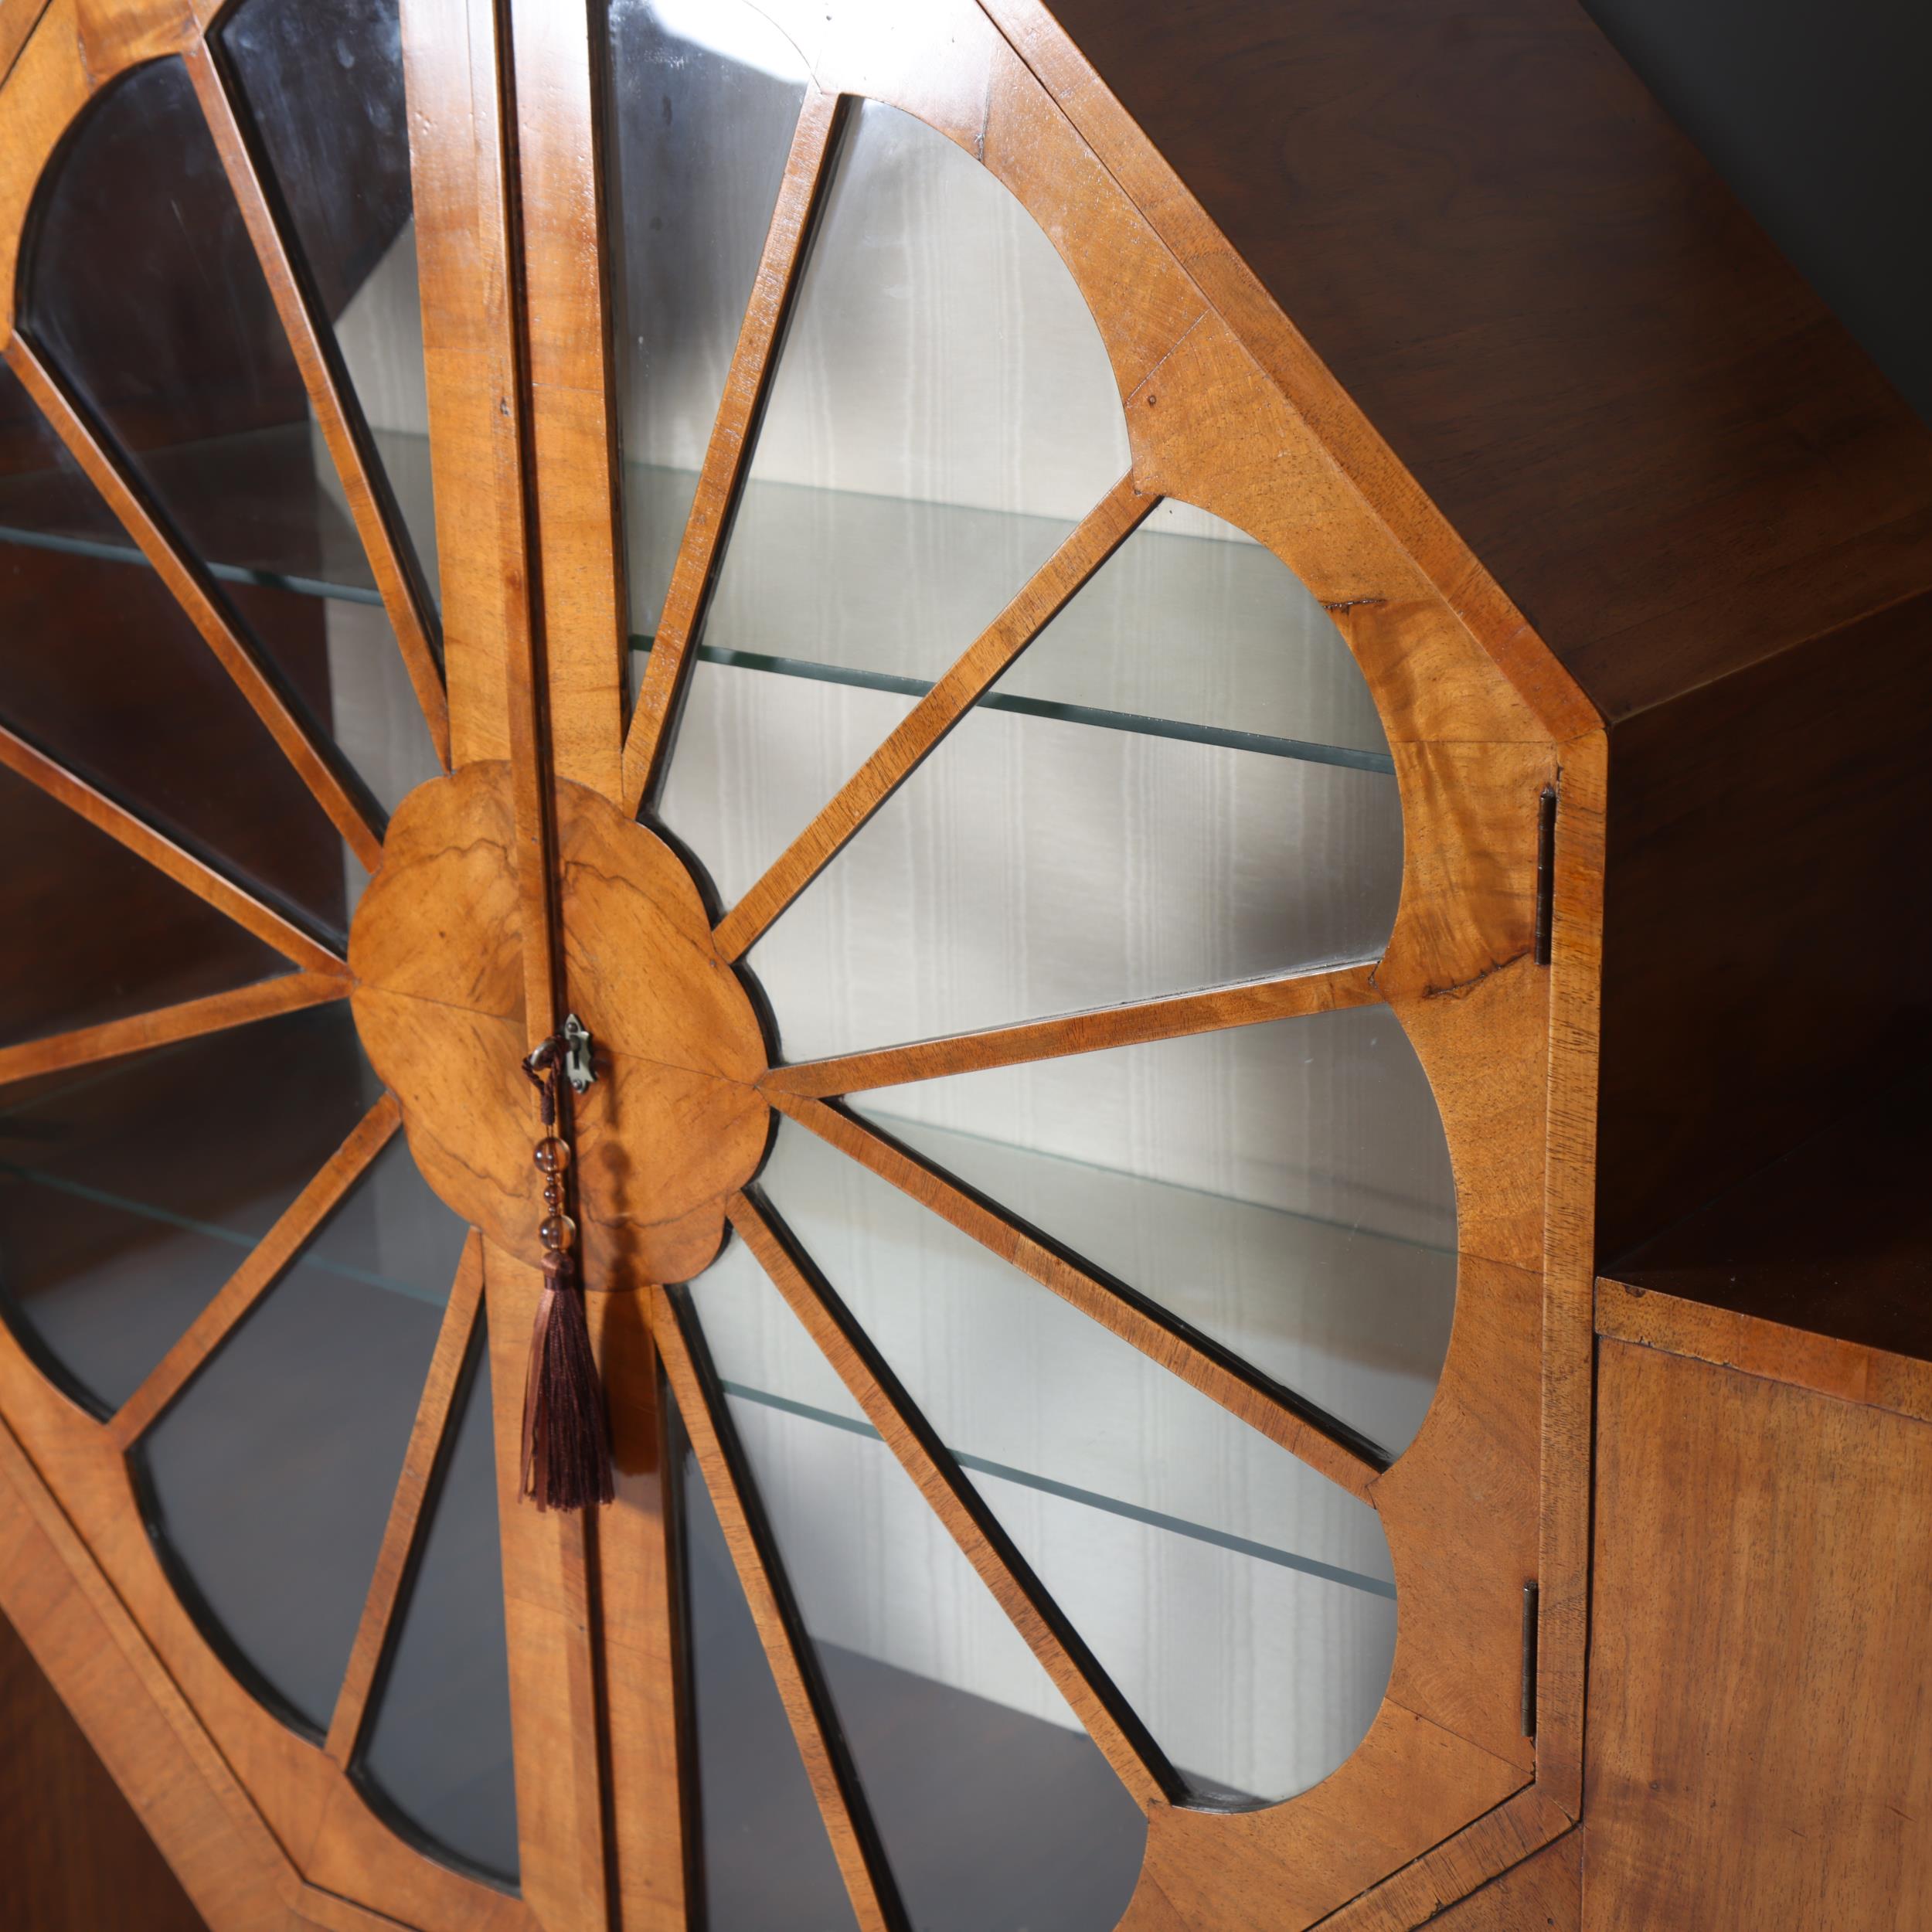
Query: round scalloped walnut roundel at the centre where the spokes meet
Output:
[[350, 764, 771, 1289]]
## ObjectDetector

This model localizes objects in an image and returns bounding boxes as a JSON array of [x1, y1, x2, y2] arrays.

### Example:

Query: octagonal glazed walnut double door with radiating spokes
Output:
[[0, 0, 1588, 1932]]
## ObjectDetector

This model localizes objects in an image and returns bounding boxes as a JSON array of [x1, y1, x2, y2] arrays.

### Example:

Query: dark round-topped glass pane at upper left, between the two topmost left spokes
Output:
[[22, 53, 427, 835]]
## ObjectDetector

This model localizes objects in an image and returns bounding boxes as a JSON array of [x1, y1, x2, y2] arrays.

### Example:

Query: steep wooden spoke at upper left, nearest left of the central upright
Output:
[[185, 39, 451, 765]]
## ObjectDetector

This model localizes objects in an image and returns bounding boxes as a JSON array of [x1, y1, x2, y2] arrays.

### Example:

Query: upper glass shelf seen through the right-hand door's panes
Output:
[[624, 464, 1395, 775]]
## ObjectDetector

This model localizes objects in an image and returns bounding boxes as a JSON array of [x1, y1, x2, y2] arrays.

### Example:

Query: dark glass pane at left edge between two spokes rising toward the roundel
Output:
[[0, 1001, 375, 1414]]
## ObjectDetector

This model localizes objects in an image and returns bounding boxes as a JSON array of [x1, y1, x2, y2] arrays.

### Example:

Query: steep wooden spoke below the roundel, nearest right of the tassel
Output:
[[651, 1289, 908, 1932]]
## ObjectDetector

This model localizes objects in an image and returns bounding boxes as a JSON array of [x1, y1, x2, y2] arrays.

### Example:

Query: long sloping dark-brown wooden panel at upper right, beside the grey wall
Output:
[[1036, 0, 1932, 719]]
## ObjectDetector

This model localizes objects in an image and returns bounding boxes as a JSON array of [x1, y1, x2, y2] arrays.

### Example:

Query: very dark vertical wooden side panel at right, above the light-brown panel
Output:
[[1596, 595, 1932, 1258]]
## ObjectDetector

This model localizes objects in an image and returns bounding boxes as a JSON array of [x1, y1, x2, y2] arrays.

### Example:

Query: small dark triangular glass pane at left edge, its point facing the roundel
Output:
[[0, 761, 290, 1046]]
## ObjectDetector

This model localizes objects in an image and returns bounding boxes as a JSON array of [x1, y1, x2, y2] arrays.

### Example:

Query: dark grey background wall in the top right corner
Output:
[[1584, 0, 1932, 423]]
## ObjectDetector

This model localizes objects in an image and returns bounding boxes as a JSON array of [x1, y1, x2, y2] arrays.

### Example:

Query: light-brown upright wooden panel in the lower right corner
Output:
[[1584, 1341, 1932, 1932]]
